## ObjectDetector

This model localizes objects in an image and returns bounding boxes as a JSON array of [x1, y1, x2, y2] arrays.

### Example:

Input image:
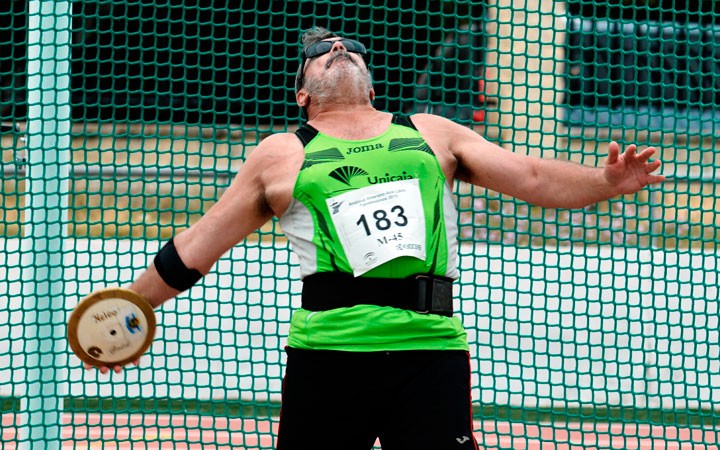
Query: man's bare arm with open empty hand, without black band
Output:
[[413, 115, 664, 208]]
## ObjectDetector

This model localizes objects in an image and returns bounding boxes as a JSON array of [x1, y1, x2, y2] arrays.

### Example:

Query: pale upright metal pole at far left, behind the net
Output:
[[18, 0, 71, 450]]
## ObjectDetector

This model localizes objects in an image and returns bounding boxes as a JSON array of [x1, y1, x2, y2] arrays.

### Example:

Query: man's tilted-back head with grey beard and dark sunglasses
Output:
[[295, 27, 375, 118]]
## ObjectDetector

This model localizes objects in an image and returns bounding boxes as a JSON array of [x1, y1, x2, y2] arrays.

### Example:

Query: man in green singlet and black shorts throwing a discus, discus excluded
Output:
[[90, 28, 664, 450]]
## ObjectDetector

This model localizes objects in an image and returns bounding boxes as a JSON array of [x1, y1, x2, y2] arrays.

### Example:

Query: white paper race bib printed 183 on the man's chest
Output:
[[327, 179, 426, 276]]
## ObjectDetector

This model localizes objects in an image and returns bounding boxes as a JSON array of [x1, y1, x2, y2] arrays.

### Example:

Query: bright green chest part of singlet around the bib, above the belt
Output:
[[293, 116, 447, 277]]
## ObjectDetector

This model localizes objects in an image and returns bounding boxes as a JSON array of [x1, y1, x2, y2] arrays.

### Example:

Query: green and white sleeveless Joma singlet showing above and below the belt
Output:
[[280, 115, 468, 351]]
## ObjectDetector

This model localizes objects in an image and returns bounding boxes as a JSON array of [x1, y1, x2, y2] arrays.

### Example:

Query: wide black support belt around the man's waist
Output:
[[302, 272, 453, 317]]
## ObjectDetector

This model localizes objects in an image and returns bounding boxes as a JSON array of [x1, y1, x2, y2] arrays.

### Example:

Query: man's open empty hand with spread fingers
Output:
[[605, 141, 665, 194]]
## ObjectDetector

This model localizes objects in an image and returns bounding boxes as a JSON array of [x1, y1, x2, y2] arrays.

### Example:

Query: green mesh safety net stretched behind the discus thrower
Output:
[[0, 0, 720, 449]]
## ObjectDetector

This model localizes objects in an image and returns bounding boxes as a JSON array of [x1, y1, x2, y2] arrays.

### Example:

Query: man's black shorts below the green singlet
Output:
[[277, 348, 478, 450]]
